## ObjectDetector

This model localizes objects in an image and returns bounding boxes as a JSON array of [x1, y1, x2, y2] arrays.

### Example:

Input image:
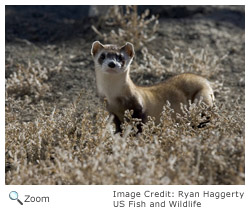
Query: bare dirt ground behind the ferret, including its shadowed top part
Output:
[[5, 6, 245, 184]]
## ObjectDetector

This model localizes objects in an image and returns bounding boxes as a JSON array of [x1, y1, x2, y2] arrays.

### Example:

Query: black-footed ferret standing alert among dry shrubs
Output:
[[91, 41, 214, 132]]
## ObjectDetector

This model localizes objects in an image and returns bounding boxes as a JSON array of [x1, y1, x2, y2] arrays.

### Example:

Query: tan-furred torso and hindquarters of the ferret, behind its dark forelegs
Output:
[[136, 73, 214, 123]]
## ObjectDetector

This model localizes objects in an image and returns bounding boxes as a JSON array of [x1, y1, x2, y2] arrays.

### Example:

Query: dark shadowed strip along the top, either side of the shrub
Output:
[[5, 5, 245, 42]]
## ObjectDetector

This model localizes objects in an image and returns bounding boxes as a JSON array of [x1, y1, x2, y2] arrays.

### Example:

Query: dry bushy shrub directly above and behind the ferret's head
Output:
[[92, 5, 159, 50]]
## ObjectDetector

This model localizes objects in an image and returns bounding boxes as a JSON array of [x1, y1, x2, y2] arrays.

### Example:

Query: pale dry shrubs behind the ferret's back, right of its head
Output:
[[134, 47, 226, 78]]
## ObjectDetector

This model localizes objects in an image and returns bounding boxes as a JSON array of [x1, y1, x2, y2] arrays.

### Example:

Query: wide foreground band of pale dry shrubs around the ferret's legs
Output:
[[6, 93, 245, 184]]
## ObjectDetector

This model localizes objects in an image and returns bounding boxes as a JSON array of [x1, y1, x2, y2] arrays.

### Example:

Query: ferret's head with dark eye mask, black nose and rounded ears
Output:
[[91, 41, 135, 74]]
